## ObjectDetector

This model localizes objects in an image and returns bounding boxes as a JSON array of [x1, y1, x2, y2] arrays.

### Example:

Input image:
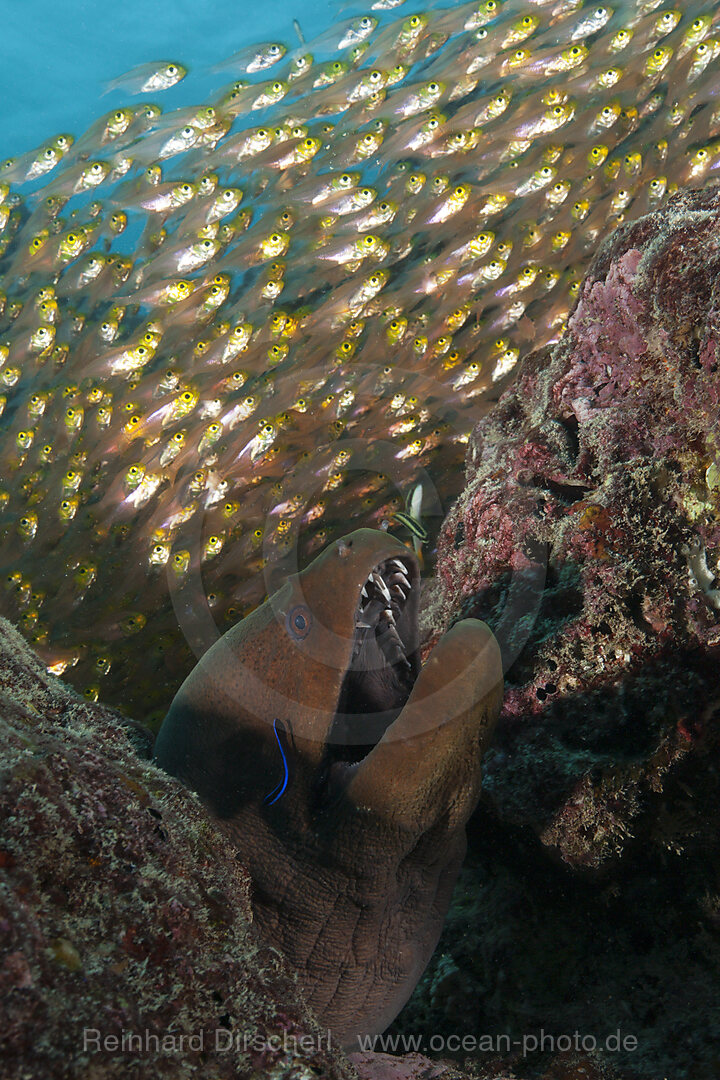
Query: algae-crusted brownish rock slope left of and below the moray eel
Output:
[[0, 620, 356, 1080]]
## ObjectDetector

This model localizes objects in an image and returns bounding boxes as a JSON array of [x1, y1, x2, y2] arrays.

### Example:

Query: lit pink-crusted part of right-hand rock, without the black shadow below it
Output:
[[425, 187, 720, 867]]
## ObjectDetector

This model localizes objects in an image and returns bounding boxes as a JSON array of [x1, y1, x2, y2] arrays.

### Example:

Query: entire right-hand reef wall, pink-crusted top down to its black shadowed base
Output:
[[400, 186, 720, 1080]]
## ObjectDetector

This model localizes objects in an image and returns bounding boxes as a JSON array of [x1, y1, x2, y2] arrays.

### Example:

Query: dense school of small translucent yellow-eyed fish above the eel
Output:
[[0, 0, 720, 715]]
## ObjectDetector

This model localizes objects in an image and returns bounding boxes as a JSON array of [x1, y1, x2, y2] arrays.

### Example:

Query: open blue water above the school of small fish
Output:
[[0, 0, 362, 160]]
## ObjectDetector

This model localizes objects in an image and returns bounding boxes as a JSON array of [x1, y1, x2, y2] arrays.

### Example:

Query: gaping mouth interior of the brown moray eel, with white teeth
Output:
[[328, 553, 420, 762]]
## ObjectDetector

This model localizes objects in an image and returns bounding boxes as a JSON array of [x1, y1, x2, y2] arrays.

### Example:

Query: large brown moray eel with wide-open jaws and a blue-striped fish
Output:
[[155, 529, 503, 1043]]
